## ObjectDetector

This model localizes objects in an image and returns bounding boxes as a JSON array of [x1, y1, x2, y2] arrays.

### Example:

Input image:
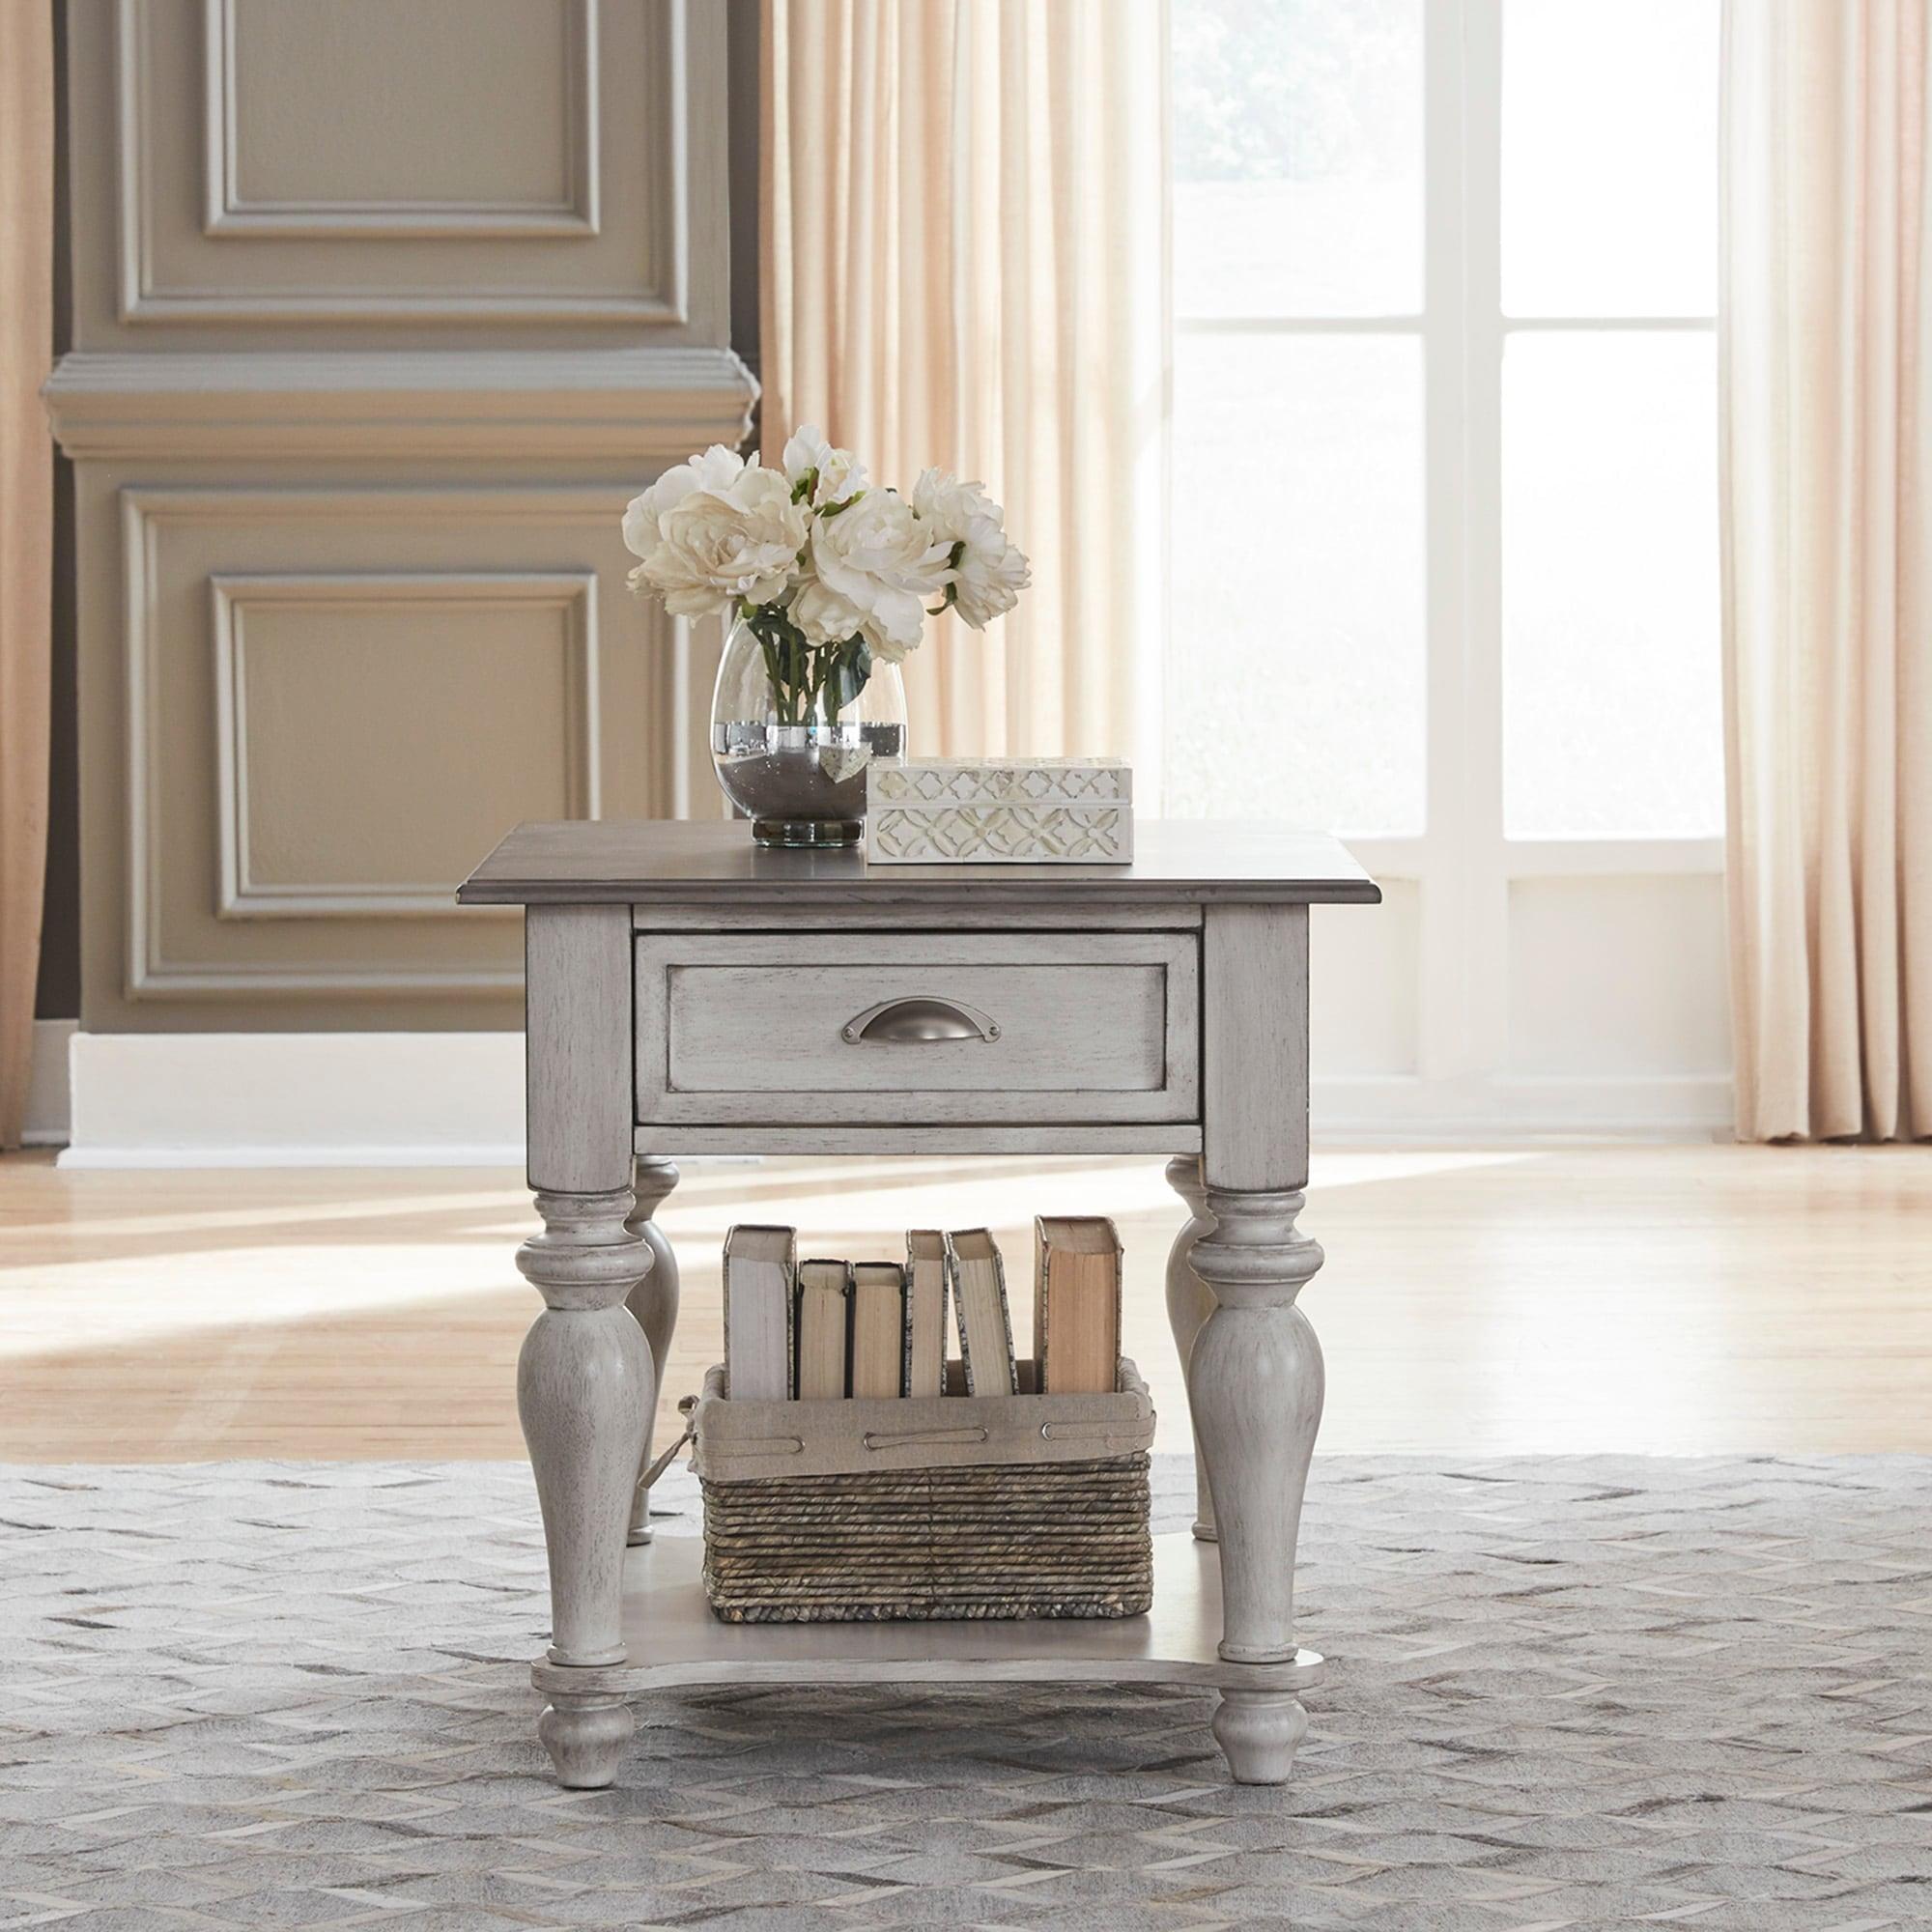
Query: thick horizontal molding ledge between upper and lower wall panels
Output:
[[43, 348, 757, 469]]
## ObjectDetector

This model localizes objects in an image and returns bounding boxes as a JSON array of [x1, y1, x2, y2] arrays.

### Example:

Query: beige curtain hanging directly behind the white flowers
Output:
[[761, 0, 1167, 755]]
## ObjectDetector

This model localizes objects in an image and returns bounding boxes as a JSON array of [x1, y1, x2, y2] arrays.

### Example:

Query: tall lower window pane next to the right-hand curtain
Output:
[[1503, 332, 1723, 838]]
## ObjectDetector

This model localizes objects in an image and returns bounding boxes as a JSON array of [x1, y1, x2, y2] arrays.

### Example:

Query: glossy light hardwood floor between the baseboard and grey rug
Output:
[[0, 1148, 1932, 1461]]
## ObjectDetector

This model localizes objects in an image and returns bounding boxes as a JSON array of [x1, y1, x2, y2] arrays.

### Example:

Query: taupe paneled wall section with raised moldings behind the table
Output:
[[48, 0, 753, 1034]]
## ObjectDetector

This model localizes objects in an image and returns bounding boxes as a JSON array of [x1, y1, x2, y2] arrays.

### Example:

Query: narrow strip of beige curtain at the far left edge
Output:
[[0, 0, 54, 1148]]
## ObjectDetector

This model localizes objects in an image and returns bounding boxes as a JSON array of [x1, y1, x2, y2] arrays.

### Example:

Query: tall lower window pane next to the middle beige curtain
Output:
[[1161, 336, 1424, 835]]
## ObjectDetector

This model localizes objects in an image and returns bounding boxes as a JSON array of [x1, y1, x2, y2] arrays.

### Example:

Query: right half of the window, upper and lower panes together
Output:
[[1499, 0, 1723, 838]]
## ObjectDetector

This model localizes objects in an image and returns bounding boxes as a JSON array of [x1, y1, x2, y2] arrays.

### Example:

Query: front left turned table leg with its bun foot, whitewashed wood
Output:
[[516, 1188, 657, 1789]]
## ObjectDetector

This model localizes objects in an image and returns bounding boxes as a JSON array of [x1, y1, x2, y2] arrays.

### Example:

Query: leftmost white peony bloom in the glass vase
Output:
[[624, 444, 810, 616]]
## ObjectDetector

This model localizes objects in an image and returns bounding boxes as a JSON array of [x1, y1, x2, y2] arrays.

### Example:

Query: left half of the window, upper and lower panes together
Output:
[[1161, 0, 1428, 835]]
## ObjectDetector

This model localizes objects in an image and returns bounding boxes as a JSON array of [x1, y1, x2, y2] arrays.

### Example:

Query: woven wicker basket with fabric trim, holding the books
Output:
[[692, 1360, 1153, 1623]]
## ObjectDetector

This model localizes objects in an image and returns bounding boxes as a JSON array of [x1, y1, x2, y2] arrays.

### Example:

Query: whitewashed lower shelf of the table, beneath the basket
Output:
[[529, 1536, 1321, 1694]]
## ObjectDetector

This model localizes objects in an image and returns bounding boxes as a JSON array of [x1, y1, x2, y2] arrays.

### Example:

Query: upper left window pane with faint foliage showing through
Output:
[[1173, 0, 1422, 315]]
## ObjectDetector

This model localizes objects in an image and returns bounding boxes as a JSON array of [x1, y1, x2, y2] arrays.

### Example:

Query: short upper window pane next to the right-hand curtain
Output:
[[1503, 0, 1718, 315]]
